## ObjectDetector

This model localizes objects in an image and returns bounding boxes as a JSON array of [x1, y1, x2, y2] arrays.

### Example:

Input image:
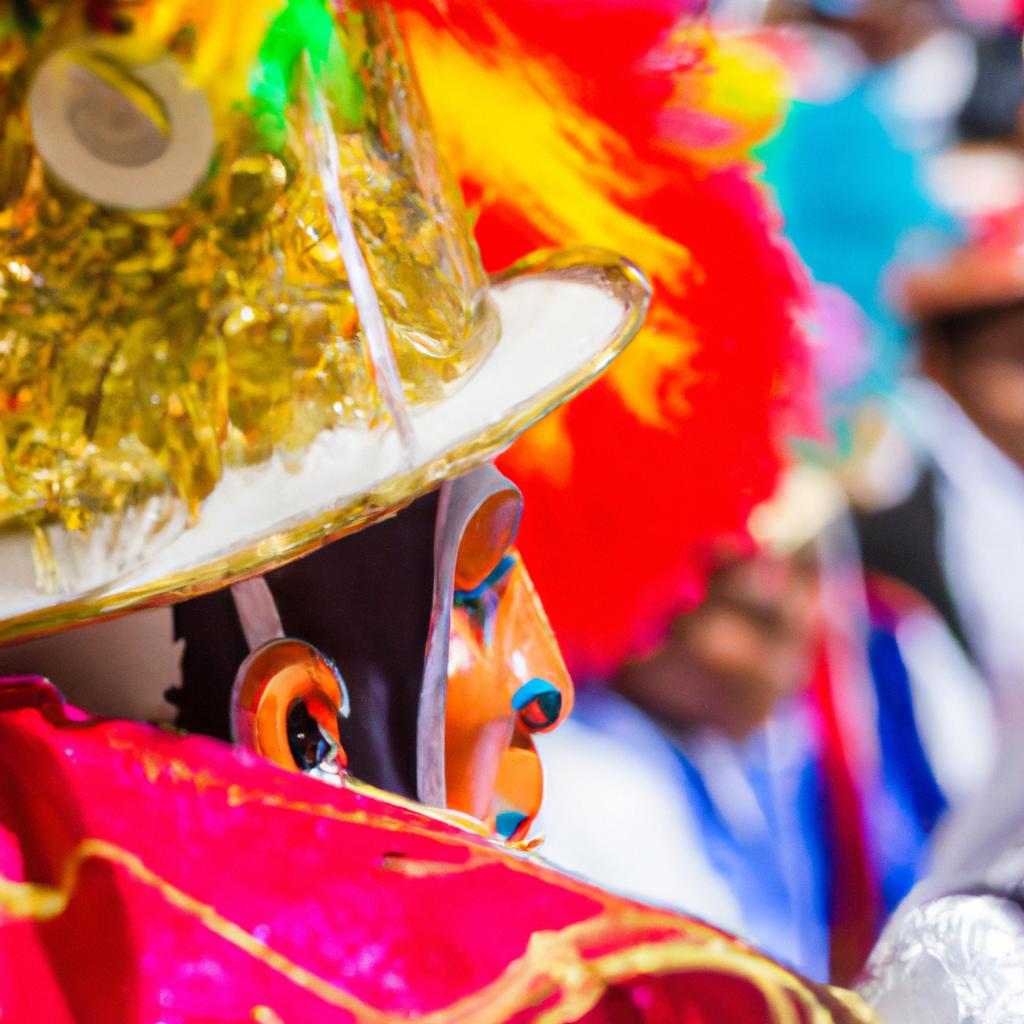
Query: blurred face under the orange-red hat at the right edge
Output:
[[925, 303, 1024, 469]]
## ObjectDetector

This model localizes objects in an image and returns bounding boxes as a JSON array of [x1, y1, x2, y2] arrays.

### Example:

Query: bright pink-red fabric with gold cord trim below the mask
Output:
[[0, 679, 864, 1024]]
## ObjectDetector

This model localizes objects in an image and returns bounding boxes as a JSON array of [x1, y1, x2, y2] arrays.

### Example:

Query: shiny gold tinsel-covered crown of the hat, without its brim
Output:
[[0, 0, 500, 592]]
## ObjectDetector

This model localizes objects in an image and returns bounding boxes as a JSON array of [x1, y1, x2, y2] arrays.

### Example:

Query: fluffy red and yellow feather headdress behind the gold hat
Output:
[[402, 0, 806, 680]]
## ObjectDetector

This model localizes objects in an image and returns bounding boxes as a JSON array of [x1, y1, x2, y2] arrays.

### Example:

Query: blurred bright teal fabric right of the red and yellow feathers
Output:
[[759, 68, 959, 440]]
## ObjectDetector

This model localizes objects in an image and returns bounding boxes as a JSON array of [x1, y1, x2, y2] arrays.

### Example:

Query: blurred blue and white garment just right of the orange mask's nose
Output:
[[537, 689, 829, 980]]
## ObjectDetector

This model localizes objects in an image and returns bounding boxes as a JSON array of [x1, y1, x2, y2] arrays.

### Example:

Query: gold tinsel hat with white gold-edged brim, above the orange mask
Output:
[[0, 0, 648, 640]]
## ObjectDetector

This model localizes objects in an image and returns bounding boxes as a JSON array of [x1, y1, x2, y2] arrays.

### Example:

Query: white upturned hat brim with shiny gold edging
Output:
[[0, 250, 649, 642]]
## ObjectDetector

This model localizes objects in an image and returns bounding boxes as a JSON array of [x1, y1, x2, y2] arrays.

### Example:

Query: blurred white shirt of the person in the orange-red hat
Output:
[[908, 383, 1024, 884]]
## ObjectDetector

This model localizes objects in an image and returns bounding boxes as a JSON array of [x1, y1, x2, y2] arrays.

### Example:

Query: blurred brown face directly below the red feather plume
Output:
[[616, 555, 816, 739]]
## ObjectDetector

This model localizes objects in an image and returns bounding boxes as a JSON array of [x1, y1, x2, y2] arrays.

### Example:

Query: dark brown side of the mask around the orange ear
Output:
[[174, 495, 437, 799]]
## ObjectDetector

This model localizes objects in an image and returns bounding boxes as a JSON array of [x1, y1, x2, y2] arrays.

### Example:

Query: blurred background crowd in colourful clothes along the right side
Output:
[[541, 0, 1024, 982]]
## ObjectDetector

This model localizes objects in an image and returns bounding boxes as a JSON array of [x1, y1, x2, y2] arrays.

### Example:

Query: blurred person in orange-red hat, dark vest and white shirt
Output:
[[860, 208, 1024, 790]]
